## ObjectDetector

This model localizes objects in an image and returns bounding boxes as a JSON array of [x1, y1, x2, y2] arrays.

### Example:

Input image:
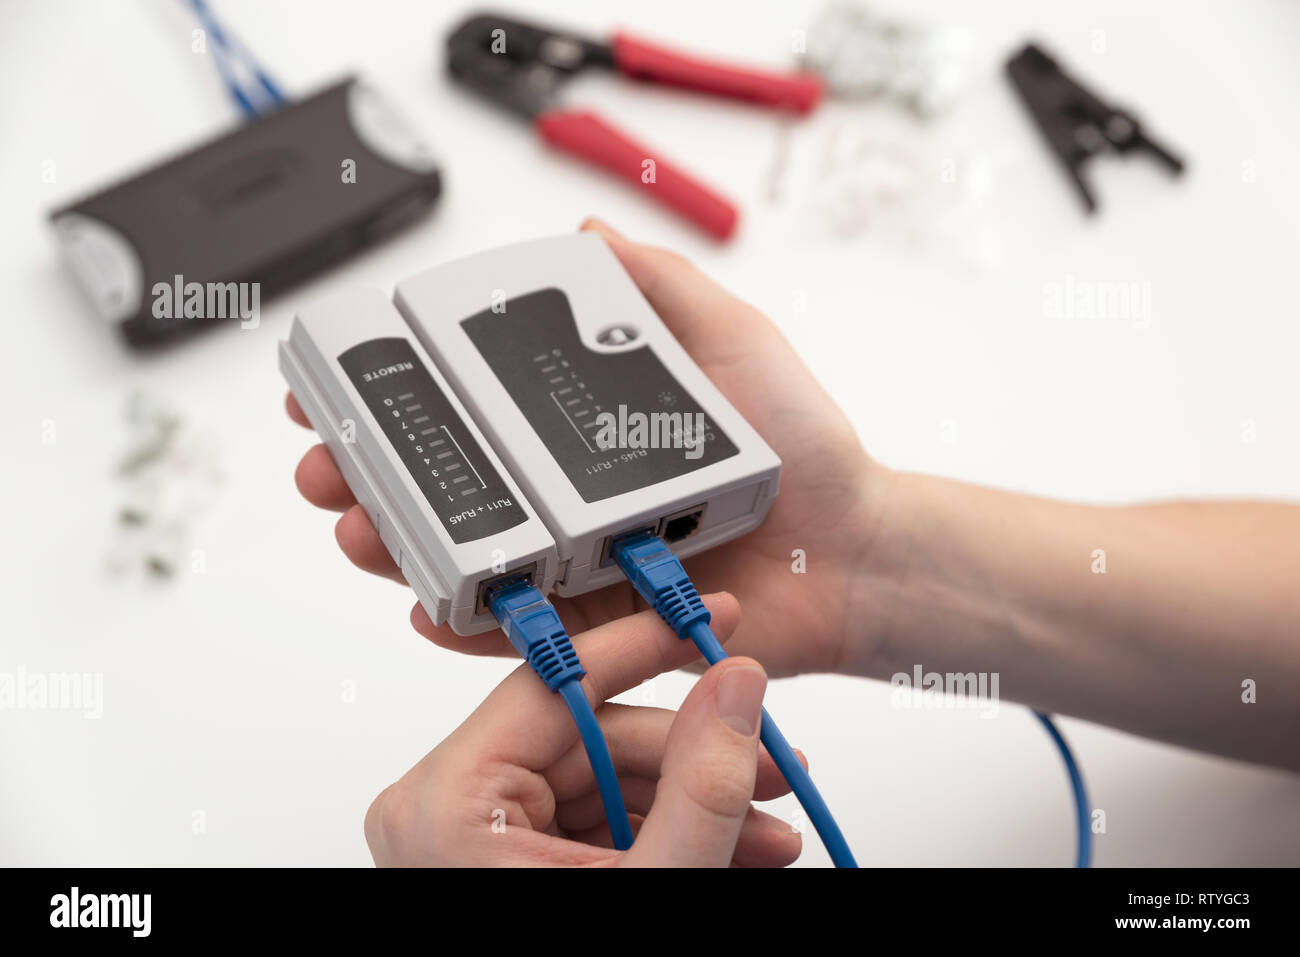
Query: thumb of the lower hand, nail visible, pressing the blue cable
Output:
[[624, 658, 767, 867]]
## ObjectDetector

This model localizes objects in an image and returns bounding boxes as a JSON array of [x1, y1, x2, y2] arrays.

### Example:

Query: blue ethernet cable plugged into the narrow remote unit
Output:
[[485, 579, 632, 850]]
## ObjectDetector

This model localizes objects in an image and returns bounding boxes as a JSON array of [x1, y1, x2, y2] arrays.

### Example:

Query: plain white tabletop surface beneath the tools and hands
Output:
[[0, 0, 1300, 865]]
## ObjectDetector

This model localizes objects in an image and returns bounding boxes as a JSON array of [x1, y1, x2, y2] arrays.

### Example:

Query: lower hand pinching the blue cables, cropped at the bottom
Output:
[[365, 594, 802, 867]]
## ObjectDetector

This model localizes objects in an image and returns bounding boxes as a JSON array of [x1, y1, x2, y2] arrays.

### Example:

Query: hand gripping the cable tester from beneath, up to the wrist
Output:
[[287, 221, 892, 676]]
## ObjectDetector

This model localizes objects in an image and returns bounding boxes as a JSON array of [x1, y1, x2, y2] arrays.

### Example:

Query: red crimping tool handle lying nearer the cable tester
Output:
[[536, 109, 736, 239]]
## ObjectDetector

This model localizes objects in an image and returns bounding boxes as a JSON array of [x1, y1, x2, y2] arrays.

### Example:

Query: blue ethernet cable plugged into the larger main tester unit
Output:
[[612, 531, 858, 867]]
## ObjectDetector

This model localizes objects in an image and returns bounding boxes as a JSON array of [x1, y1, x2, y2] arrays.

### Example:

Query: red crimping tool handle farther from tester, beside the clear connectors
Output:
[[610, 33, 822, 113]]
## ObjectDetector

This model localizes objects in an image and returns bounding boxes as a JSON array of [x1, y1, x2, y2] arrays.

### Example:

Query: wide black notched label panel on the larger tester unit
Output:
[[460, 289, 737, 502]]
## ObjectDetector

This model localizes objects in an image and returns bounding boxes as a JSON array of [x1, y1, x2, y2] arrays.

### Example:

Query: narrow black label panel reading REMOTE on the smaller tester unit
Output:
[[338, 337, 528, 545]]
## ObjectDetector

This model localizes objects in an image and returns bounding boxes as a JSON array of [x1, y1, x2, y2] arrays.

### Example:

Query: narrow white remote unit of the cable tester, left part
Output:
[[280, 290, 558, 635]]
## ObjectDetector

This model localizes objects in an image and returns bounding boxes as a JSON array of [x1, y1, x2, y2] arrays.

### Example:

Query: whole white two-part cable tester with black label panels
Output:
[[280, 233, 781, 635]]
